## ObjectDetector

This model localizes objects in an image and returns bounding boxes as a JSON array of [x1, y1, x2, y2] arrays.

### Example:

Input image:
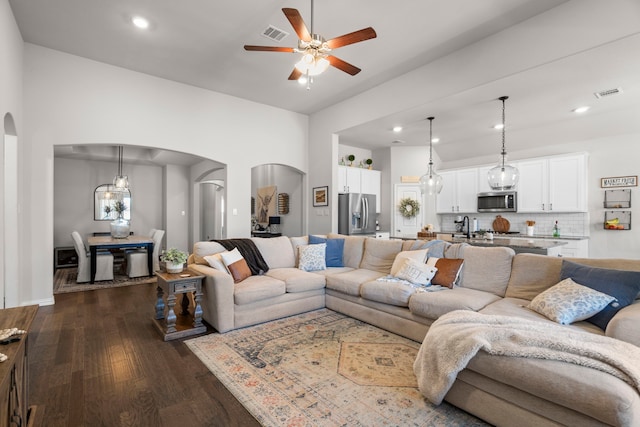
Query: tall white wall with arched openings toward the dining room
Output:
[[21, 44, 308, 308]]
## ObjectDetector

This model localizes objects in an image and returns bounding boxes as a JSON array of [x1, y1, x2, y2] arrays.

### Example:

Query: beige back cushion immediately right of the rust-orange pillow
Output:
[[460, 246, 516, 297]]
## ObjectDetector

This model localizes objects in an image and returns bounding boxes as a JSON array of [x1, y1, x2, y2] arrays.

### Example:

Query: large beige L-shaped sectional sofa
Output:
[[188, 234, 640, 426]]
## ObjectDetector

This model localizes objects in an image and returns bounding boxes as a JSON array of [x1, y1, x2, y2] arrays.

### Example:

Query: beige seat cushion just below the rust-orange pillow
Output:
[[409, 288, 500, 319]]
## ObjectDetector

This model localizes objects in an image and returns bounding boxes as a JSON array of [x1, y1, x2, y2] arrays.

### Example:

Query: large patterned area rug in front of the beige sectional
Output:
[[185, 309, 487, 427]]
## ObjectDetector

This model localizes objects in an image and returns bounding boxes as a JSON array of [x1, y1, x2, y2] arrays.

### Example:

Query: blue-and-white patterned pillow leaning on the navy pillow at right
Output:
[[527, 279, 615, 325]]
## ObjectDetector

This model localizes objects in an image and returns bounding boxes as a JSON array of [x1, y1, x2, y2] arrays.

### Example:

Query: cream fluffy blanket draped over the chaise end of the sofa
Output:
[[413, 310, 640, 405]]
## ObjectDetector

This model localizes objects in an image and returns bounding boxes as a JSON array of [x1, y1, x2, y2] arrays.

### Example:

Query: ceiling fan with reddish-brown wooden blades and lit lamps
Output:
[[244, 0, 377, 88]]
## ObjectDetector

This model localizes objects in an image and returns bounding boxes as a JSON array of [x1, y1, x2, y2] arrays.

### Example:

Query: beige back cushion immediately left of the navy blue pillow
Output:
[[505, 254, 562, 301]]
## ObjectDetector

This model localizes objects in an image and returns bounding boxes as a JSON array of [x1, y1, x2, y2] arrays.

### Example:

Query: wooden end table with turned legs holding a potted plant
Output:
[[153, 269, 207, 341]]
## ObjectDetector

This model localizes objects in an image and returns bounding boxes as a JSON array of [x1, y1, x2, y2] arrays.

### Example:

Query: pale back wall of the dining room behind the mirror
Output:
[[53, 157, 164, 247]]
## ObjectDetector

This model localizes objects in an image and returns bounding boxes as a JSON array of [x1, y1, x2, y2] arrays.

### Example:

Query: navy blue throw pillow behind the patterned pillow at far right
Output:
[[560, 260, 640, 331]]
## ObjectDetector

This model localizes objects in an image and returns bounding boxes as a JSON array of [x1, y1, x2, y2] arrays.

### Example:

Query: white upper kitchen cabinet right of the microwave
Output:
[[518, 154, 587, 212]]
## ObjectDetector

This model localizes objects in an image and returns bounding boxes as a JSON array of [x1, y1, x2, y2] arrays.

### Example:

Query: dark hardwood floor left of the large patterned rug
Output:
[[29, 284, 260, 427]]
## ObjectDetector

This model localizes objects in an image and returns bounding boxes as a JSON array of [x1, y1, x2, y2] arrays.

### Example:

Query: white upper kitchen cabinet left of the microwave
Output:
[[436, 168, 478, 213]]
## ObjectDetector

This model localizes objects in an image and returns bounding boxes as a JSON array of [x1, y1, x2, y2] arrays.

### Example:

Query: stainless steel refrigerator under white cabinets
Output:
[[338, 193, 376, 235]]
